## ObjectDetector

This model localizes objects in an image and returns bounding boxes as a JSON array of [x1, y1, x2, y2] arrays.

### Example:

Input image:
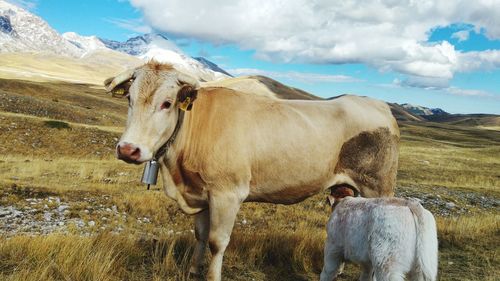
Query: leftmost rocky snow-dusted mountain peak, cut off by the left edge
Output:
[[0, 0, 83, 57]]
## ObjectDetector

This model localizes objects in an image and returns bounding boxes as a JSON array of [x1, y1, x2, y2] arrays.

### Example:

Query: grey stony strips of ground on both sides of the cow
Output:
[[0, 184, 500, 237]]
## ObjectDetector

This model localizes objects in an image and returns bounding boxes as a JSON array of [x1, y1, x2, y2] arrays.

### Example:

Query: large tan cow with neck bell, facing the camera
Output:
[[105, 62, 399, 280]]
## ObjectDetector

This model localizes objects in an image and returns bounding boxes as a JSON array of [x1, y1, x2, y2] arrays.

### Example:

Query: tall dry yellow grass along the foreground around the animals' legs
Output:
[[0, 215, 500, 281]]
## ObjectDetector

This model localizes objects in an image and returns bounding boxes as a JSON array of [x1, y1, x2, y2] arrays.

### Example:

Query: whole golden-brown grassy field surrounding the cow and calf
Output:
[[0, 80, 500, 281]]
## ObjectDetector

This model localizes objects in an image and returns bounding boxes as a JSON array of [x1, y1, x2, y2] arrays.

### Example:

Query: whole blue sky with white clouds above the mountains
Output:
[[10, 0, 500, 114]]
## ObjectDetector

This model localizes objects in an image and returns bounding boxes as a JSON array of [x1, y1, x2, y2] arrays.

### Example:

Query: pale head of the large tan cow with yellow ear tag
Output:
[[104, 62, 199, 164]]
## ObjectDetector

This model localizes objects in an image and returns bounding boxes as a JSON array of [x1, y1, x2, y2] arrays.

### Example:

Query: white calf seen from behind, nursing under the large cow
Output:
[[320, 192, 438, 281]]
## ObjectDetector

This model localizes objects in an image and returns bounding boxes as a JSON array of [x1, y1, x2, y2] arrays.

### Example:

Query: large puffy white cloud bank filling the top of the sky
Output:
[[130, 0, 500, 87]]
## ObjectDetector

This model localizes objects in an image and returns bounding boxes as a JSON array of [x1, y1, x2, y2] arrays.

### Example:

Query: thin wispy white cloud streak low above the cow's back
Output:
[[227, 68, 361, 83]]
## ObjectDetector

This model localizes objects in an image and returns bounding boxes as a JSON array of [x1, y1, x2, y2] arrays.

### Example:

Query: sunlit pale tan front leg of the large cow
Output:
[[207, 191, 242, 281]]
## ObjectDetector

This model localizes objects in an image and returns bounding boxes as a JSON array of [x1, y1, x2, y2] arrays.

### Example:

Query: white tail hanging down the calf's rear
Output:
[[409, 199, 438, 281]]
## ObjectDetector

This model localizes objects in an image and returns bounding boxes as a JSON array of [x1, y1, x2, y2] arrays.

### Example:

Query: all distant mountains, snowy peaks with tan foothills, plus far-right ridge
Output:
[[0, 0, 500, 124]]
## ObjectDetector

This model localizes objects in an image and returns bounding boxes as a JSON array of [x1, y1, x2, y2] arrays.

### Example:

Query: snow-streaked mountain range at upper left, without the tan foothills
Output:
[[0, 0, 229, 81]]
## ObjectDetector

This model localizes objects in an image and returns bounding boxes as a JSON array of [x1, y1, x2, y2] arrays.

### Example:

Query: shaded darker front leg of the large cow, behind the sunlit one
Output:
[[189, 209, 210, 277]]
